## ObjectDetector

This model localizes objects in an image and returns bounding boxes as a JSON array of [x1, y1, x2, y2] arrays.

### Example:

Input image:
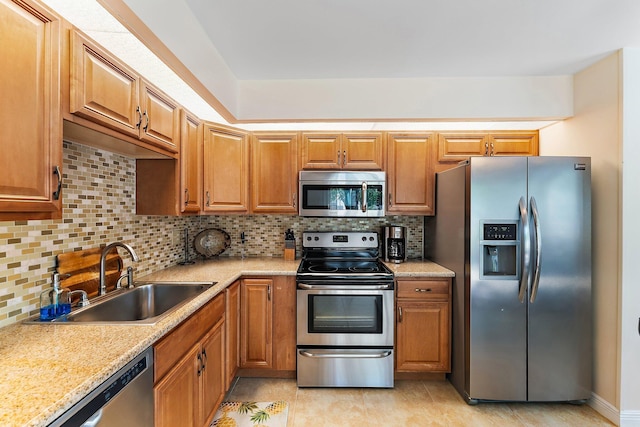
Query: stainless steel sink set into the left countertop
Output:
[[27, 282, 215, 325]]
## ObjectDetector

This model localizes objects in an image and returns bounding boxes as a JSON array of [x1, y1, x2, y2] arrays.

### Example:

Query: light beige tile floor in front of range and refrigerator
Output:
[[225, 378, 613, 427]]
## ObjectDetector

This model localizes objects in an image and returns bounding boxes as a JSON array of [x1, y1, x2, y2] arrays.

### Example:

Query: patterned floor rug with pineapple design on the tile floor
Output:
[[211, 400, 289, 427]]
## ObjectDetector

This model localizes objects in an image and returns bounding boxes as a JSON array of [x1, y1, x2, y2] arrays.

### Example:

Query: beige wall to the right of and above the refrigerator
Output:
[[540, 53, 622, 418]]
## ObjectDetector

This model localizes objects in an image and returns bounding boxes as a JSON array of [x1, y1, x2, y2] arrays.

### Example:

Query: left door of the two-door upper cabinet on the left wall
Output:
[[69, 31, 142, 138]]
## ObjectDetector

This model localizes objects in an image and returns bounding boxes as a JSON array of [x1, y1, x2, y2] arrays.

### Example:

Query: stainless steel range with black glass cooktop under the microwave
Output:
[[296, 232, 394, 387]]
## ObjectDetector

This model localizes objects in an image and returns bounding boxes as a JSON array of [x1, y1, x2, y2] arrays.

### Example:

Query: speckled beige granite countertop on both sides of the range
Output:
[[0, 257, 453, 426]]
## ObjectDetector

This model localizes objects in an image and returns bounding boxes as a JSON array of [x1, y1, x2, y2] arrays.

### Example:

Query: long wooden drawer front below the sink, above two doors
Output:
[[154, 293, 224, 382]]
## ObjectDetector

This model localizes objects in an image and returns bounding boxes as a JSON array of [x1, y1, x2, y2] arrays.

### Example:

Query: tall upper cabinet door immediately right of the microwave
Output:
[[387, 132, 435, 215]]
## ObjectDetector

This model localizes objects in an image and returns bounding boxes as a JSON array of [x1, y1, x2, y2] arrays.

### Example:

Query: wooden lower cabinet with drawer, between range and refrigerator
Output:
[[396, 278, 451, 373]]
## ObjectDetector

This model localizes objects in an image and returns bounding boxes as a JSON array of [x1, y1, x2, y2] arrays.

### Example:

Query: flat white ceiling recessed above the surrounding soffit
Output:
[[180, 0, 640, 80]]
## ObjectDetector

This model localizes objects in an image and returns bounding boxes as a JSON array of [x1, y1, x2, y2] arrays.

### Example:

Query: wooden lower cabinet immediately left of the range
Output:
[[240, 276, 296, 374]]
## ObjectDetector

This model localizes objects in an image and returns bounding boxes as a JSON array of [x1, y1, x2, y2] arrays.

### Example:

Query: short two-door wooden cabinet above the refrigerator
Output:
[[438, 131, 538, 162]]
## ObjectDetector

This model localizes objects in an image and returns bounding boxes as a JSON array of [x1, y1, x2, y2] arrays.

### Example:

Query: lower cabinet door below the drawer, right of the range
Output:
[[396, 300, 450, 372]]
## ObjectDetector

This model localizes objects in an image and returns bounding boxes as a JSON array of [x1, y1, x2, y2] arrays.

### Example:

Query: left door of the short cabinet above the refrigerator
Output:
[[438, 132, 490, 163]]
